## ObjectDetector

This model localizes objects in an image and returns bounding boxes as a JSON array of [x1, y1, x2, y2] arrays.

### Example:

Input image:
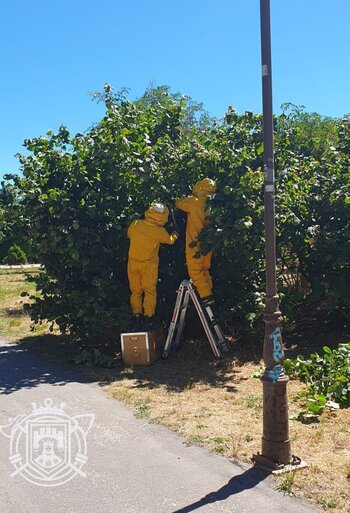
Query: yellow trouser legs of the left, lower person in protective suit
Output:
[[128, 258, 158, 317]]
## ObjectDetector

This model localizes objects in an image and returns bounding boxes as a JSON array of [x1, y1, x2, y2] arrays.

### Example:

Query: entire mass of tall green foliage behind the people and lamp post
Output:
[[3, 85, 350, 337]]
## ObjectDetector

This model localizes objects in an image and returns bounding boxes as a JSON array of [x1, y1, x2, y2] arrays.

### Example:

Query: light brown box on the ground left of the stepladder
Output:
[[120, 331, 164, 365]]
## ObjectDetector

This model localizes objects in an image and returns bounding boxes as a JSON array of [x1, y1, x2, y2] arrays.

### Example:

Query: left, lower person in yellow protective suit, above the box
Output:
[[128, 203, 179, 331]]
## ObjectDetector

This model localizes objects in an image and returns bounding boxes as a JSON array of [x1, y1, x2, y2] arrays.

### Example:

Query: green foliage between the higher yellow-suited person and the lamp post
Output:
[[200, 109, 265, 329]]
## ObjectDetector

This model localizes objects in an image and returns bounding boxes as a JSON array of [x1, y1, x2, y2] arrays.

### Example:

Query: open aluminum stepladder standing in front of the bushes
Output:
[[163, 280, 229, 358]]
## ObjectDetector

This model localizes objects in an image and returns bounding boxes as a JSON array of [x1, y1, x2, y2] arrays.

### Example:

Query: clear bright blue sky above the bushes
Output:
[[0, 0, 350, 181]]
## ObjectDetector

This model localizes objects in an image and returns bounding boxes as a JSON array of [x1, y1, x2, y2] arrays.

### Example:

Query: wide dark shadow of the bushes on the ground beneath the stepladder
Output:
[[6, 320, 348, 394]]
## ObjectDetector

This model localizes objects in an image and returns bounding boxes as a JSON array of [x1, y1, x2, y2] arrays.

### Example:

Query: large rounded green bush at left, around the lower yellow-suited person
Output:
[[13, 87, 205, 338]]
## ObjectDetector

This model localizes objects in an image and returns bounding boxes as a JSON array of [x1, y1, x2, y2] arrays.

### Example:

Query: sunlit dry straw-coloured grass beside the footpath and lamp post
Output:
[[0, 271, 350, 513]]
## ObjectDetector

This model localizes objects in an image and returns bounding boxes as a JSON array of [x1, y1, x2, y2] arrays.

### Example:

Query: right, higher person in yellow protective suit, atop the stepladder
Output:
[[176, 178, 216, 305]]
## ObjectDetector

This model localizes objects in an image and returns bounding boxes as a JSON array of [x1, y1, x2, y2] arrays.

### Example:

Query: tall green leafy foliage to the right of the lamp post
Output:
[[276, 111, 350, 329]]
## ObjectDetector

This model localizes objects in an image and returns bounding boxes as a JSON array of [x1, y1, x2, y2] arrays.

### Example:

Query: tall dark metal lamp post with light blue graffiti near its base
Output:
[[253, 0, 300, 470]]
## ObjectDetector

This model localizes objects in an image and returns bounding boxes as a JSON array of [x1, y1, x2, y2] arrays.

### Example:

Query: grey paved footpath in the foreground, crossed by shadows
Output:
[[0, 341, 319, 513]]
